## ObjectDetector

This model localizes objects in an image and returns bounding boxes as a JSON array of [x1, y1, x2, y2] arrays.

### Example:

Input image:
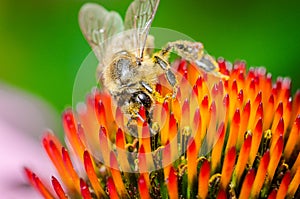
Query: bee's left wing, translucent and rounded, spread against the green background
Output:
[[79, 3, 124, 67]]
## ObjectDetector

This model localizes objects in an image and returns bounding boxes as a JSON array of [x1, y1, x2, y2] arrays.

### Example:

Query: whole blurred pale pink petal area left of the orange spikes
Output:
[[0, 84, 60, 199]]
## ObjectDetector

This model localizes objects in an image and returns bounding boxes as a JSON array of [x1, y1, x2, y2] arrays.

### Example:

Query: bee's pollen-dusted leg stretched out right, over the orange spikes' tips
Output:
[[159, 40, 228, 79]]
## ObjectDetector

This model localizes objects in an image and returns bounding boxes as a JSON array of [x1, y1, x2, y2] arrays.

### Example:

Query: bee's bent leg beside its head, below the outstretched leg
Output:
[[153, 54, 178, 98]]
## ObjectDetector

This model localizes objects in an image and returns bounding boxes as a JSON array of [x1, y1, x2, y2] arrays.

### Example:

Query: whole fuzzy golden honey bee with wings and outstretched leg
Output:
[[79, 0, 226, 123]]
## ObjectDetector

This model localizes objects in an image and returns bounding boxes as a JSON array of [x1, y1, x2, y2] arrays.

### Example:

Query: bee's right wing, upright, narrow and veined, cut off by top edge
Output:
[[125, 0, 159, 59]]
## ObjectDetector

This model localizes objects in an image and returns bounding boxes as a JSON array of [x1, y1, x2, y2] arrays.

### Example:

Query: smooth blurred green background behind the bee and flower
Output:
[[0, 0, 300, 112]]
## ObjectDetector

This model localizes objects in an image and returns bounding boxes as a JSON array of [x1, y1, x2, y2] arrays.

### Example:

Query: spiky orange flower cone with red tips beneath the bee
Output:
[[25, 59, 300, 199]]
